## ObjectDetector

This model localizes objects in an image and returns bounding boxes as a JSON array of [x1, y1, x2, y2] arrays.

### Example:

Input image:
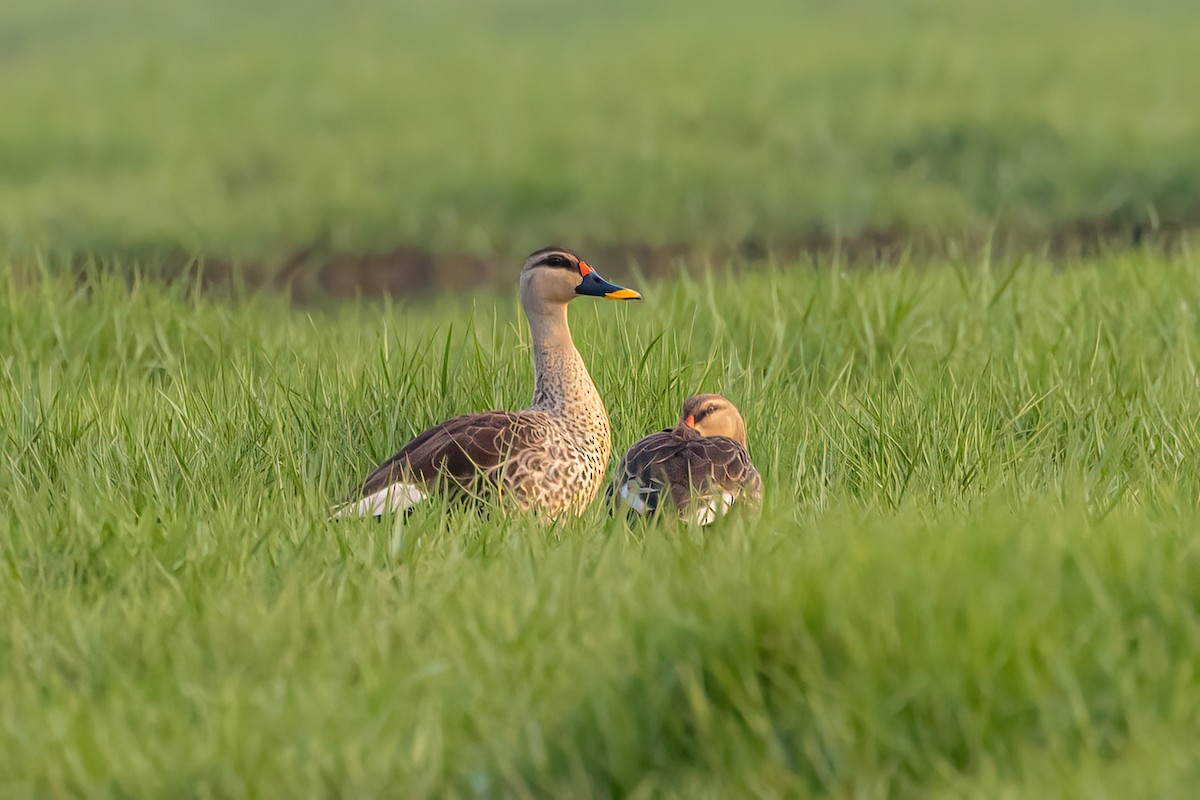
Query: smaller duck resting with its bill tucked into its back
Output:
[[607, 395, 762, 525]]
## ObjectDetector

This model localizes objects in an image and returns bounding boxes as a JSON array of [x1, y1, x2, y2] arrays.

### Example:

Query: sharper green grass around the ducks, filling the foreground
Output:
[[0, 247, 1200, 796]]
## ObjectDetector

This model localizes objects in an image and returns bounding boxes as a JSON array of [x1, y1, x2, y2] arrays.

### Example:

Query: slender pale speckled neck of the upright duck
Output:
[[526, 303, 608, 428]]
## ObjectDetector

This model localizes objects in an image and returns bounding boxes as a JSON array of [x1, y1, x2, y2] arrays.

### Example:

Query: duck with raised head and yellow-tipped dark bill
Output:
[[335, 247, 641, 517]]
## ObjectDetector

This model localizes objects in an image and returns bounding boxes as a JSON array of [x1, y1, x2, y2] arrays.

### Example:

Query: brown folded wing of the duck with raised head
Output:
[[353, 411, 542, 500]]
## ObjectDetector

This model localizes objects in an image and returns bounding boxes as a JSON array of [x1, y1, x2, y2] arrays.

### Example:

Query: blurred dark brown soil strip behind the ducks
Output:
[[63, 213, 1200, 305]]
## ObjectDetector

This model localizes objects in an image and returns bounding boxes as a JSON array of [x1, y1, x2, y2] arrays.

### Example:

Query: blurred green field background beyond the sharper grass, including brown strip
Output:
[[0, 0, 1200, 296]]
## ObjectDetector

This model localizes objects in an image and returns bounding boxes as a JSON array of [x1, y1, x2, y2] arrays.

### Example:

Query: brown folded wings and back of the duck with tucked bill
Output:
[[607, 428, 762, 513]]
